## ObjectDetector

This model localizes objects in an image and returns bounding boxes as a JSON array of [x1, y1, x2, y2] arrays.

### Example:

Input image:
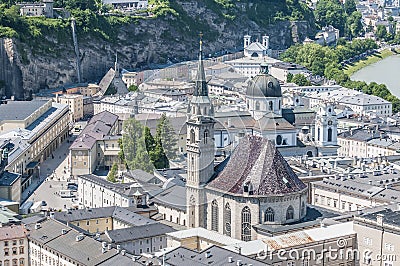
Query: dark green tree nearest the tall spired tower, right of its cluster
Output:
[[155, 113, 178, 160]]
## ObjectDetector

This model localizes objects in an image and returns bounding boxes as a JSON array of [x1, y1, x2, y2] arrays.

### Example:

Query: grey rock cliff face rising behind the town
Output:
[[0, 0, 314, 99]]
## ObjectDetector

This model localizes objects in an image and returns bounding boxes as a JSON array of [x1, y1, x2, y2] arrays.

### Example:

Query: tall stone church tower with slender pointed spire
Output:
[[186, 36, 215, 227]]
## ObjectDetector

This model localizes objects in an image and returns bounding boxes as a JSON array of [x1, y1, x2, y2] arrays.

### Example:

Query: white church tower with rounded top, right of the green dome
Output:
[[315, 102, 337, 146]]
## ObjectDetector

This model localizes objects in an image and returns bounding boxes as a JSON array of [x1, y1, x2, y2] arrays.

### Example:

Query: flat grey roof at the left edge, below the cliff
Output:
[[0, 100, 48, 121]]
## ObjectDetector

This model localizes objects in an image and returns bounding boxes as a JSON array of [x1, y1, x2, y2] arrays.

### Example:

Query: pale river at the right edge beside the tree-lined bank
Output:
[[351, 55, 400, 98]]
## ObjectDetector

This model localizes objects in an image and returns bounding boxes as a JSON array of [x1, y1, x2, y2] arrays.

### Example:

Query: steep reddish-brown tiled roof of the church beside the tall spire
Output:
[[207, 135, 306, 196]]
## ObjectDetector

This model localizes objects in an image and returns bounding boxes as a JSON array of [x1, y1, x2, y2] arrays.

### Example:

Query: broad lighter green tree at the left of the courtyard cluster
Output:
[[122, 118, 154, 173]]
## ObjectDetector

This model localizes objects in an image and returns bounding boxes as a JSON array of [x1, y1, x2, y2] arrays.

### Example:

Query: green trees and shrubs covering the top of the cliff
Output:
[[0, 0, 313, 45]]
